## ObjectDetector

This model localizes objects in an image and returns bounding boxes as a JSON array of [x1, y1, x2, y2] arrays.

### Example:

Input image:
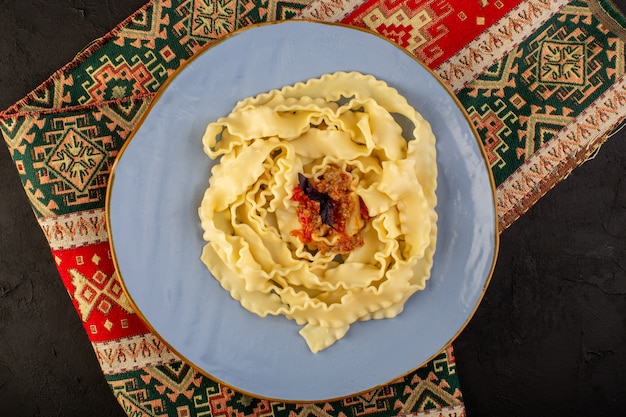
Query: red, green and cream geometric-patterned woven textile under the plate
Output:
[[0, 0, 626, 417]]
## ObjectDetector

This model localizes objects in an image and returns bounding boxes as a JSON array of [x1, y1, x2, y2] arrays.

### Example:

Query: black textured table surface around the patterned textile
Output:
[[0, 0, 626, 417]]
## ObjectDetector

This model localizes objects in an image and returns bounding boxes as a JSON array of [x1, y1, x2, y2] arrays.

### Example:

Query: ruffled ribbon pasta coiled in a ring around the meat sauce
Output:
[[199, 72, 437, 352]]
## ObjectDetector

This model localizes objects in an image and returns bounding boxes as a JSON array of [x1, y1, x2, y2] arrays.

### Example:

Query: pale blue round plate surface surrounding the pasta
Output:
[[107, 21, 498, 401]]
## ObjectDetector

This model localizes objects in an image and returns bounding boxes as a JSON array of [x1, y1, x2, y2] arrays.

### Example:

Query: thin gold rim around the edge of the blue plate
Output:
[[105, 19, 500, 404]]
